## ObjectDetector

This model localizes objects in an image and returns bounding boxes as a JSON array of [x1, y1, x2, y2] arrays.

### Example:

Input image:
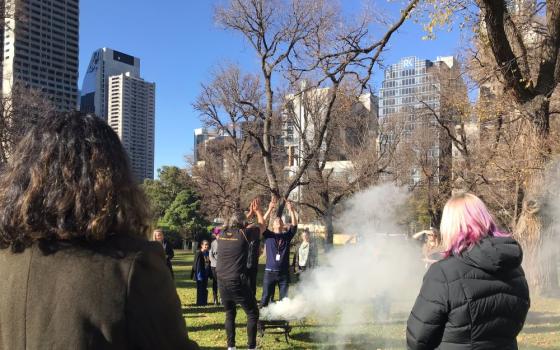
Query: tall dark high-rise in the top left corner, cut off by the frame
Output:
[[0, 0, 79, 111]]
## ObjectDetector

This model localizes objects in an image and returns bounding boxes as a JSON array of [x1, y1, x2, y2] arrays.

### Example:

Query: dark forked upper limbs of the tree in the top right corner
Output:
[[477, 0, 560, 138]]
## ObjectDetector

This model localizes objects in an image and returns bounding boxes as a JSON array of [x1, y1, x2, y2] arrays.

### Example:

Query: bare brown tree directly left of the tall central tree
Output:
[[193, 65, 270, 215]]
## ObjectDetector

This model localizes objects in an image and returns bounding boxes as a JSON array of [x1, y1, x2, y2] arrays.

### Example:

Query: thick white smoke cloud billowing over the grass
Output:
[[261, 184, 424, 346]]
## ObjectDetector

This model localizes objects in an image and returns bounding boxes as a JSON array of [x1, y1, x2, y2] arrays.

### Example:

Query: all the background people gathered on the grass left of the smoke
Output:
[[158, 197, 317, 349]]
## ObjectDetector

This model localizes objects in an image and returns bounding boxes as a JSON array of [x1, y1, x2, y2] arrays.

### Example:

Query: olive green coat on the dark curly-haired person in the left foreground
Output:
[[0, 235, 198, 350]]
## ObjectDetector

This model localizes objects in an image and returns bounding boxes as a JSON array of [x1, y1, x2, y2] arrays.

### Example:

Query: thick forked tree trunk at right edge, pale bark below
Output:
[[477, 0, 560, 293]]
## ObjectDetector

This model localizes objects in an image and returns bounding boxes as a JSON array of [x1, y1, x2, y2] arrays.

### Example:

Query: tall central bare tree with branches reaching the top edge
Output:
[[216, 0, 418, 215]]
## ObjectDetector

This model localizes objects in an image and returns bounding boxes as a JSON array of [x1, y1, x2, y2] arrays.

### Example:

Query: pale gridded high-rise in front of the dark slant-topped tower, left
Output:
[[108, 73, 155, 182]]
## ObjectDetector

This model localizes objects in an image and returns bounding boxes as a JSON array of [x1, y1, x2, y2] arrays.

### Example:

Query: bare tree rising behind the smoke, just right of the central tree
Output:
[[286, 86, 397, 245]]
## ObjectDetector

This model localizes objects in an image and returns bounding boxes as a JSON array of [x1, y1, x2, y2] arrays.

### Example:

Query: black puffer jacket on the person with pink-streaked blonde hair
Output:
[[406, 237, 529, 350]]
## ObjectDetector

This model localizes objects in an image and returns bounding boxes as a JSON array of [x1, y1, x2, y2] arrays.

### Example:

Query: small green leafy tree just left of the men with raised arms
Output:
[[162, 189, 210, 241]]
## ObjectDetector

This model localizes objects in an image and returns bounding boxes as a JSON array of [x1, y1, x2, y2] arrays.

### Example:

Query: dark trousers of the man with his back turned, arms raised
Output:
[[218, 276, 259, 349]]
